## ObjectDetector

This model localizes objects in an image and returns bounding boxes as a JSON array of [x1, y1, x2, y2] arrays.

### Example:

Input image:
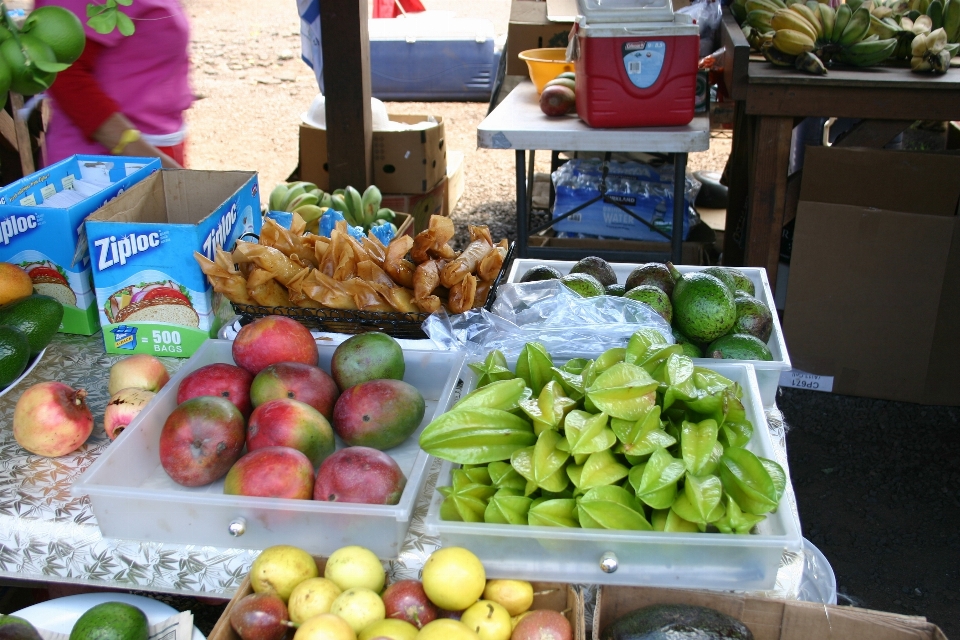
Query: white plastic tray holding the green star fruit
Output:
[[425, 354, 803, 590]]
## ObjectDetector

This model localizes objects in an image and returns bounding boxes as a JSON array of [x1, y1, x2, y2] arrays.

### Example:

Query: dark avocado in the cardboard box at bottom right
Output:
[[600, 604, 753, 640]]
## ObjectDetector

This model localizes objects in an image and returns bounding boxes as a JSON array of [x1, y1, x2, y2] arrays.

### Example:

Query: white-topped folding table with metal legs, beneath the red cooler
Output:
[[477, 82, 710, 264]]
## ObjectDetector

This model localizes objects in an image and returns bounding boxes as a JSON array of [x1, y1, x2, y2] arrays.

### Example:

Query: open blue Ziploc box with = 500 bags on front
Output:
[[86, 169, 261, 358]]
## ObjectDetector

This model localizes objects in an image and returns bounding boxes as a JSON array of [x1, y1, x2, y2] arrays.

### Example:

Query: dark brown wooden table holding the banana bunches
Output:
[[721, 15, 960, 282]]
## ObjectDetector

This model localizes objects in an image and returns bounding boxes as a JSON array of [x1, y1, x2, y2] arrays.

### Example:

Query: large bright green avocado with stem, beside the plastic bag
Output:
[[667, 263, 737, 342]]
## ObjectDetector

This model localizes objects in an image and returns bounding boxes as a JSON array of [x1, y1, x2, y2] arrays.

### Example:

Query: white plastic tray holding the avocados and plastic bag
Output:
[[506, 258, 791, 407]]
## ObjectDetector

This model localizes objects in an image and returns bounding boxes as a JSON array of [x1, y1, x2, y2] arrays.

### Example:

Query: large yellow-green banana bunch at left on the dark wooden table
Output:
[[747, 0, 900, 74]]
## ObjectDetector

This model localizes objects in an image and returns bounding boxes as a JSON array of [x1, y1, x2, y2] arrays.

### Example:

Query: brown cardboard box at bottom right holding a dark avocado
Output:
[[593, 587, 947, 640]]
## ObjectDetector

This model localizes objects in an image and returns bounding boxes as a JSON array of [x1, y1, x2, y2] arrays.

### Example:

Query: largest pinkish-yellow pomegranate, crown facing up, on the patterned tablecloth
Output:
[[13, 381, 93, 458]]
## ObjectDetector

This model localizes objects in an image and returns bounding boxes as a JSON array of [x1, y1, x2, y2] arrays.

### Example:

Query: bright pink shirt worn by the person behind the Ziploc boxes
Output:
[[35, 0, 193, 164]]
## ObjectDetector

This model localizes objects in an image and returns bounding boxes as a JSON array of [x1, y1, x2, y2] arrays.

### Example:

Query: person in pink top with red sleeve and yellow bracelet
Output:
[[35, 0, 193, 168]]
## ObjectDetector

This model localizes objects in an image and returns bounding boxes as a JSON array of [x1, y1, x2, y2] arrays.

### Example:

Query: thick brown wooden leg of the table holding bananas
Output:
[[743, 116, 793, 286]]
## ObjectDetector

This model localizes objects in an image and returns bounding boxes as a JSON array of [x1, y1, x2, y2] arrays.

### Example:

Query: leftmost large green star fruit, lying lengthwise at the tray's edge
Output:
[[420, 409, 537, 464]]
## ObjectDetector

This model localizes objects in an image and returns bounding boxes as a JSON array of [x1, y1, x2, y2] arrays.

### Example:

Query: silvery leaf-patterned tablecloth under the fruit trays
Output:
[[0, 334, 804, 598]]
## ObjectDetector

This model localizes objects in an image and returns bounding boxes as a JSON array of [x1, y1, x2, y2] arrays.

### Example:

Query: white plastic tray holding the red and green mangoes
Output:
[[73, 340, 464, 558]]
